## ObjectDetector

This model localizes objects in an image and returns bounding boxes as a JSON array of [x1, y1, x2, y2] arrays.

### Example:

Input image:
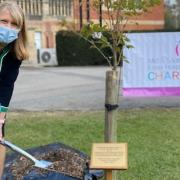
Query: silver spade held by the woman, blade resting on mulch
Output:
[[0, 140, 53, 169]]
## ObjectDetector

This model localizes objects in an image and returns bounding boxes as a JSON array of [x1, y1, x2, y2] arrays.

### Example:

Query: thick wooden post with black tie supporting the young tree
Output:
[[105, 70, 119, 180]]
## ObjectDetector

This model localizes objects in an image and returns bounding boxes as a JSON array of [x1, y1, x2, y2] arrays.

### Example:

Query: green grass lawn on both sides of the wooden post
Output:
[[6, 109, 180, 180]]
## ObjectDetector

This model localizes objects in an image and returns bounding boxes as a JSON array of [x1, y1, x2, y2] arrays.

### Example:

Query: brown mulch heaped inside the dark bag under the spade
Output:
[[5, 144, 89, 180]]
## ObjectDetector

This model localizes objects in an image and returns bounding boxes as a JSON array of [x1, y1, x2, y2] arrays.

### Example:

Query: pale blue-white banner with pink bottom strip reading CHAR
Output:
[[123, 32, 180, 95]]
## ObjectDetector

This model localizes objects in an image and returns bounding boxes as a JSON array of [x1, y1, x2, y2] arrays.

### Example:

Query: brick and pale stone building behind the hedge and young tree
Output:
[[0, 0, 164, 63]]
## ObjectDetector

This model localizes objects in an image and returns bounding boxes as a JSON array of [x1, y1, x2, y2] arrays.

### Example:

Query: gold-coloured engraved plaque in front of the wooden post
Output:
[[90, 143, 128, 170]]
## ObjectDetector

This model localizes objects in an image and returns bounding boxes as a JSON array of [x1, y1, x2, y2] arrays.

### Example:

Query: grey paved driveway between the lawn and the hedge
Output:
[[10, 66, 180, 111]]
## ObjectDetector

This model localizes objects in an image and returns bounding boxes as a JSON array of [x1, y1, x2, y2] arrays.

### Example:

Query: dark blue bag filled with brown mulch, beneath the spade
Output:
[[3, 143, 89, 180]]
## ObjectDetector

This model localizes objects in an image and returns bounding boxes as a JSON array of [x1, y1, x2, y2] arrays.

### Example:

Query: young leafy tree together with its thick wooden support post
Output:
[[81, 0, 162, 180]]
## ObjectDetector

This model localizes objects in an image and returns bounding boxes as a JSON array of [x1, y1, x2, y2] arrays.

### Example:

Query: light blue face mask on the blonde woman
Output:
[[0, 26, 19, 44]]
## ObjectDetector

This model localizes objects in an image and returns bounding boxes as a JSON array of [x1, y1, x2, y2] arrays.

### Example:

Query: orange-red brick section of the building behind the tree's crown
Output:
[[74, 0, 165, 30]]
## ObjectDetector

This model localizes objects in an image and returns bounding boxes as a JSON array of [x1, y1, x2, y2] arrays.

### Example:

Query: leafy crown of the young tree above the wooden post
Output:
[[81, 0, 161, 70]]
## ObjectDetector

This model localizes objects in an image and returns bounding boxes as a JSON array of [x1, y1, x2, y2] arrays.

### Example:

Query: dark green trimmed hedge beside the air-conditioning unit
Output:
[[56, 31, 107, 66]]
